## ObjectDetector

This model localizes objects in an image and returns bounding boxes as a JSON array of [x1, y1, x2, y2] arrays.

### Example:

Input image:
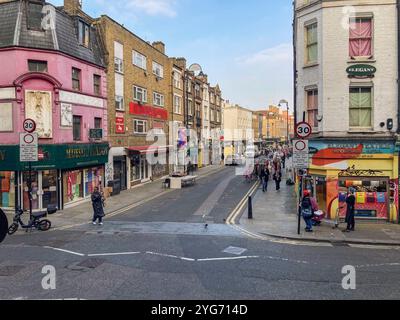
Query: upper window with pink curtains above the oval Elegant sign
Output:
[[349, 18, 372, 57]]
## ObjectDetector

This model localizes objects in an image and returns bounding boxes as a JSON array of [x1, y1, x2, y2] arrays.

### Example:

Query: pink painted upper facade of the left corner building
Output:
[[0, 48, 108, 145]]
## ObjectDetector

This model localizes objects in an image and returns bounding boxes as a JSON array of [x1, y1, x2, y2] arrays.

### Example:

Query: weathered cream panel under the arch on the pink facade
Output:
[[25, 90, 53, 139]]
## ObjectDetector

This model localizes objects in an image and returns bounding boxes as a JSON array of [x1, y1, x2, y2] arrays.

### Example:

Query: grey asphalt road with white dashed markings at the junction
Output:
[[0, 168, 400, 300]]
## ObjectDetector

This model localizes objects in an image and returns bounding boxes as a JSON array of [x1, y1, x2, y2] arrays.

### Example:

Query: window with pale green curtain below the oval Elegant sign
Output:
[[350, 88, 372, 128]]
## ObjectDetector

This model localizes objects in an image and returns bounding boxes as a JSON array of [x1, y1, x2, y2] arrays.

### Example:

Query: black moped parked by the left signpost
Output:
[[8, 206, 57, 235]]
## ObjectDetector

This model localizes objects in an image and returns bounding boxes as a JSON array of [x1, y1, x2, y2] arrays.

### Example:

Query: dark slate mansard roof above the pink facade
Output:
[[0, 0, 105, 67]]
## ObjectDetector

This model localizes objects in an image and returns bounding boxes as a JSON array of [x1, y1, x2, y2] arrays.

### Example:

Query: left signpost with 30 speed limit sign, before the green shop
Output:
[[19, 119, 39, 219]]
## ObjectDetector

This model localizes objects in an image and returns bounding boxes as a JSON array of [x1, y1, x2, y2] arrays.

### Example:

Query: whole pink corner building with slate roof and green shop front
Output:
[[0, 0, 109, 210]]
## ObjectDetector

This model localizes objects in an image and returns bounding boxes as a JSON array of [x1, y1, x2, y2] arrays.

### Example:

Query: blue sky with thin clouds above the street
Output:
[[48, 0, 293, 110]]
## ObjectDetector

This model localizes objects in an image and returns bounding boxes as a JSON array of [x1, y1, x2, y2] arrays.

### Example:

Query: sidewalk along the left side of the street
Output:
[[7, 165, 224, 230]]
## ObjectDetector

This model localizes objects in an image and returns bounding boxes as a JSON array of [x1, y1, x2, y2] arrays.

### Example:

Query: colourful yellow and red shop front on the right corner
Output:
[[303, 141, 399, 222]]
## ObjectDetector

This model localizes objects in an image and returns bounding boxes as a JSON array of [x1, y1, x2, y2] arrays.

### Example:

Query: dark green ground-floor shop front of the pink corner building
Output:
[[0, 144, 109, 210]]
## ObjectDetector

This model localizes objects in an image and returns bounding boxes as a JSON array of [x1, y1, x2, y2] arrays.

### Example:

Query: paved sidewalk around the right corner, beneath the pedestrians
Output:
[[240, 170, 400, 245]]
